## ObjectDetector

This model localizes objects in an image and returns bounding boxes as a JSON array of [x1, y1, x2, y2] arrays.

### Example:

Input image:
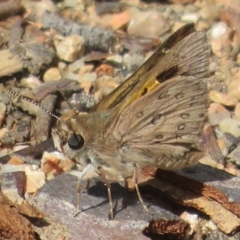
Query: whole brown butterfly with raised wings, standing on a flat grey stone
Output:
[[53, 24, 210, 219]]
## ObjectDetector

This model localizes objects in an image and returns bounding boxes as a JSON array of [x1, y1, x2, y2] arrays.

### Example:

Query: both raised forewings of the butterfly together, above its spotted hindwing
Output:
[[92, 24, 210, 111]]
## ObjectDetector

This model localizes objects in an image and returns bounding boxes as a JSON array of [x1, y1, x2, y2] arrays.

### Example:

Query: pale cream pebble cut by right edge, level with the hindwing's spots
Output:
[[219, 118, 240, 138]]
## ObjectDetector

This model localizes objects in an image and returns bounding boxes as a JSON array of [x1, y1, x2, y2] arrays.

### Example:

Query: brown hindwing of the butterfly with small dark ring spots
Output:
[[113, 76, 208, 169]]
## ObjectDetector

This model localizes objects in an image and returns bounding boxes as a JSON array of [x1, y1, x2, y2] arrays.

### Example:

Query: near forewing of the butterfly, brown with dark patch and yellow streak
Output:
[[106, 29, 210, 126]]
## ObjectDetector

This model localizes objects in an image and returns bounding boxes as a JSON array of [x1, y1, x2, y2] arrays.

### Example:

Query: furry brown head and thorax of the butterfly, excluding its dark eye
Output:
[[54, 108, 137, 181]]
